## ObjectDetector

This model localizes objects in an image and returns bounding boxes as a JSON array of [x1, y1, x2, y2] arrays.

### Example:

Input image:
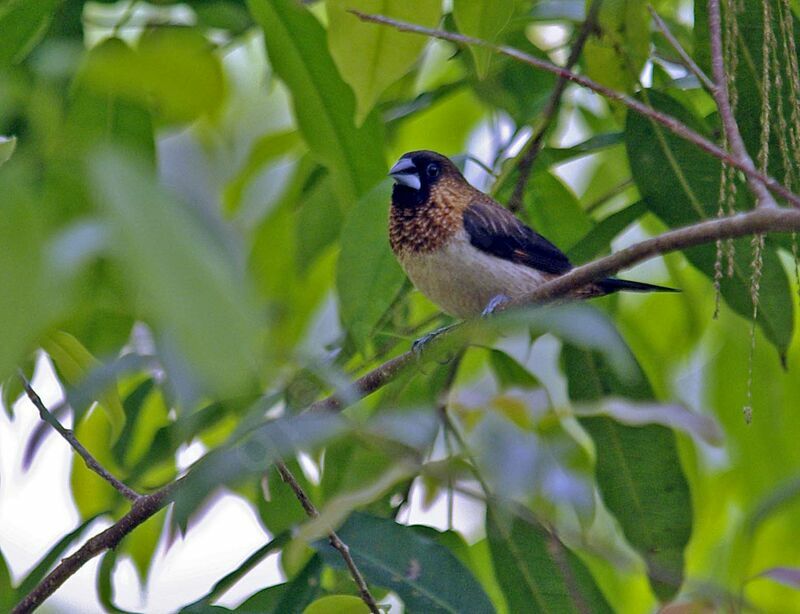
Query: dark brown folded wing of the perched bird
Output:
[[464, 202, 572, 275]]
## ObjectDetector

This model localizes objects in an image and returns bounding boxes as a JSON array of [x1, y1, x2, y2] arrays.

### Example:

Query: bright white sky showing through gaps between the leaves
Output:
[[0, 2, 700, 614]]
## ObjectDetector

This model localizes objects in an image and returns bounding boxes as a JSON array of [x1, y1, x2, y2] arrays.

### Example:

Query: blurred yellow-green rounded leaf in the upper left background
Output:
[[85, 28, 225, 123]]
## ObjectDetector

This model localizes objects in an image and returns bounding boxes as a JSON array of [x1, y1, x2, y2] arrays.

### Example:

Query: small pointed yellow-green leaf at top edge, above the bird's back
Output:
[[453, 0, 514, 79]]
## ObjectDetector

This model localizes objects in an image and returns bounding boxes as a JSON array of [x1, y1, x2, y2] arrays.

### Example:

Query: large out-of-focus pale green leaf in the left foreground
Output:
[[90, 150, 262, 396]]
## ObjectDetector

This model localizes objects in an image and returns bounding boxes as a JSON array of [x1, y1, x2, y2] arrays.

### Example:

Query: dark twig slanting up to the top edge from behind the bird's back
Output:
[[508, 0, 603, 213]]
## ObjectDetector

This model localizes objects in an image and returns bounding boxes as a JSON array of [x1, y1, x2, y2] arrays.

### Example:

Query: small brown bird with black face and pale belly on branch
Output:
[[389, 150, 677, 319]]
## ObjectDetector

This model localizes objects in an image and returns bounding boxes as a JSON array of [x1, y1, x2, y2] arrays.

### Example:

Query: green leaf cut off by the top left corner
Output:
[[0, 0, 62, 67]]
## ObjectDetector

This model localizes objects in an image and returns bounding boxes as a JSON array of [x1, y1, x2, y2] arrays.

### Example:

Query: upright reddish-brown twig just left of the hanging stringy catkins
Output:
[[708, 0, 778, 207]]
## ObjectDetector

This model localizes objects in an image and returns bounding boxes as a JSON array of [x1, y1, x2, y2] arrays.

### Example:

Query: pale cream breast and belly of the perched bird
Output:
[[398, 230, 553, 318]]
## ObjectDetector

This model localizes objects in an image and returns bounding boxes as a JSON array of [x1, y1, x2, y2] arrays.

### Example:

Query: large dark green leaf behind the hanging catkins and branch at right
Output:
[[625, 91, 794, 354]]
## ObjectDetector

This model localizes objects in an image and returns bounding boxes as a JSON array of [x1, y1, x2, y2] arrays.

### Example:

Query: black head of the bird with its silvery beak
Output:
[[389, 150, 464, 208]]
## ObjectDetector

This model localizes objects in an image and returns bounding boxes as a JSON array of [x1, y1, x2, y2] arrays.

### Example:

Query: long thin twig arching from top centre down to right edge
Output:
[[351, 10, 800, 208]]
